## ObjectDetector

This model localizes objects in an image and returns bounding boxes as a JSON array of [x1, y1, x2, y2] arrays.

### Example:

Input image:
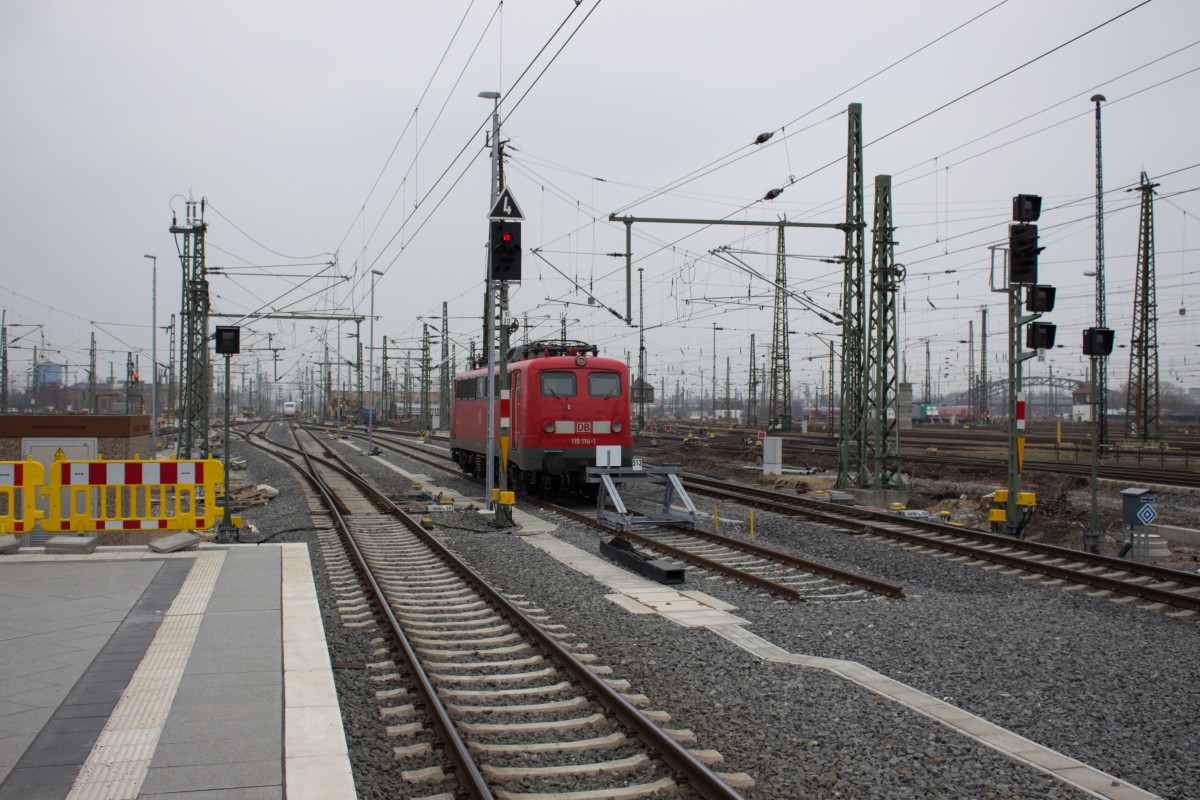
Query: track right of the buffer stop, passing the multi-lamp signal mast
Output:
[[684, 474, 1200, 616]]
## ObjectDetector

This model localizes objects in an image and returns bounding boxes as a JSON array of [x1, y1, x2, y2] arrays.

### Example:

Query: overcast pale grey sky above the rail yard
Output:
[[0, 0, 1200, 410]]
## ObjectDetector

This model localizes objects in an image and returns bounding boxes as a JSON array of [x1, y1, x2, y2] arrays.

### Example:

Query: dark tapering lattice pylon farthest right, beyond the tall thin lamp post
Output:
[[1126, 173, 1159, 441]]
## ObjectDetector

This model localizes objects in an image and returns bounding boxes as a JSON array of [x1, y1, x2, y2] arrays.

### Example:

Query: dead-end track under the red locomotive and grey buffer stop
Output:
[[324, 433, 904, 601]]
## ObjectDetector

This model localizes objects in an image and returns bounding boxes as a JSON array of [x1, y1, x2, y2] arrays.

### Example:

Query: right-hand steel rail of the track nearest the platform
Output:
[[285, 422, 744, 800]]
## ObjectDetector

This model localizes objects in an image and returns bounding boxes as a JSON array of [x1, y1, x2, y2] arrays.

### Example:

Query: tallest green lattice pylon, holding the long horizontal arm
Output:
[[836, 103, 868, 488]]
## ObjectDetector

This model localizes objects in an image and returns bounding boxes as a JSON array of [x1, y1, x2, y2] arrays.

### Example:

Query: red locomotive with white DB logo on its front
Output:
[[450, 342, 634, 492]]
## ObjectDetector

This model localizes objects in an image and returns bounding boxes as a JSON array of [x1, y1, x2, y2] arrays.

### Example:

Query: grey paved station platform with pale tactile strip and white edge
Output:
[[0, 545, 355, 800]]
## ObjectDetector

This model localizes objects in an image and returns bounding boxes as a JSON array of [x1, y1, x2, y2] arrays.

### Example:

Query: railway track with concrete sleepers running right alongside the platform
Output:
[[246, 428, 750, 800]]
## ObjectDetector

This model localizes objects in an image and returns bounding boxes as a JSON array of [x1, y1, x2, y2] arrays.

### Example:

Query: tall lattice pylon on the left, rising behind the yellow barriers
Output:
[[170, 199, 209, 458]]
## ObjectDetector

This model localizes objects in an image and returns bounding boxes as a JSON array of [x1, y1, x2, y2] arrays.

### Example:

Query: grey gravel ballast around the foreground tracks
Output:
[[234, 431, 1200, 800]]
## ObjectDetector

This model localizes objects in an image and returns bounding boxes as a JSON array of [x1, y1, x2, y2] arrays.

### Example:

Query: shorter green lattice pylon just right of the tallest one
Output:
[[859, 175, 904, 489]]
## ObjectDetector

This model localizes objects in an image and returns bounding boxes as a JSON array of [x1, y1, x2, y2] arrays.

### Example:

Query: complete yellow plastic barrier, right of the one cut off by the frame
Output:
[[42, 458, 224, 534]]
